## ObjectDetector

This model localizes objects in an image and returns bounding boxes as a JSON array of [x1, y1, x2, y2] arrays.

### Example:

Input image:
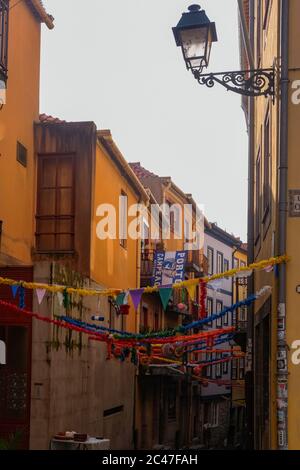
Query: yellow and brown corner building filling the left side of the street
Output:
[[0, 0, 148, 449]]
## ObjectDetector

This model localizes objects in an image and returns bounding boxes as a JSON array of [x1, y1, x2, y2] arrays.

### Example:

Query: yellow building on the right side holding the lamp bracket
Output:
[[238, 0, 300, 450]]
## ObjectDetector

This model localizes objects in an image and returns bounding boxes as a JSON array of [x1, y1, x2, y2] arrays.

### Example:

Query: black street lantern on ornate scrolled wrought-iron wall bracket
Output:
[[173, 5, 275, 98]]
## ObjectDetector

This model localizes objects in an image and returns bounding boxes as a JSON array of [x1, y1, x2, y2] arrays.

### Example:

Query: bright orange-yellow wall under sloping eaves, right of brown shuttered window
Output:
[[91, 144, 140, 331]]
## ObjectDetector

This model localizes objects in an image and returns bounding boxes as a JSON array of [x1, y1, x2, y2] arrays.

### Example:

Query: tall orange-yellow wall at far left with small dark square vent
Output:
[[0, 2, 41, 264]]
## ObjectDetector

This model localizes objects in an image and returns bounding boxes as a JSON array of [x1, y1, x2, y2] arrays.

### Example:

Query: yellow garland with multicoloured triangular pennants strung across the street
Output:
[[0, 255, 290, 306]]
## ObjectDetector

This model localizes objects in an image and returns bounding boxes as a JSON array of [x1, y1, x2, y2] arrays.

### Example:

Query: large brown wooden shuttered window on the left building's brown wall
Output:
[[36, 155, 75, 252]]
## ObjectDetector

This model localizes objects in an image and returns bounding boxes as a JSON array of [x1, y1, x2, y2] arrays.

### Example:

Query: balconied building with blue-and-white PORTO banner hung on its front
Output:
[[130, 163, 206, 449]]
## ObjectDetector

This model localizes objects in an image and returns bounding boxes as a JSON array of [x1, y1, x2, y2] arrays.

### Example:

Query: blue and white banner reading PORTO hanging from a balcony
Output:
[[152, 251, 187, 286]]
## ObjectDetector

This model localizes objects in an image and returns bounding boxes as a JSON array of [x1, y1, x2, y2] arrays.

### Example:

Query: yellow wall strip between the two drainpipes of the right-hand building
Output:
[[254, 0, 280, 449]]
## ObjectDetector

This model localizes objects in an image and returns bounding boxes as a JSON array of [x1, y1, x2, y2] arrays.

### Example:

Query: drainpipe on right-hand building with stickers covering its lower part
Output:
[[277, 0, 289, 450]]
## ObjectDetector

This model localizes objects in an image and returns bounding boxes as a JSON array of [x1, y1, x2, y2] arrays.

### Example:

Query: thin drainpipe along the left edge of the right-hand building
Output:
[[245, 0, 255, 449]]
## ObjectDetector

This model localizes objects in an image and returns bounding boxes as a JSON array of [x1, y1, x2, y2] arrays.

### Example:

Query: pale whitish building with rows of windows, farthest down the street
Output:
[[201, 224, 245, 448]]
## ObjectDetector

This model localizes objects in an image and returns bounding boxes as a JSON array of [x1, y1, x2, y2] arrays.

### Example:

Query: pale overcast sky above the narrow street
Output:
[[41, 0, 247, 240]]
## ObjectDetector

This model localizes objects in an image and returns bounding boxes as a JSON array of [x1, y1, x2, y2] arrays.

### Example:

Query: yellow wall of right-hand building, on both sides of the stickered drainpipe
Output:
[[251, 0, 300, 450]]
